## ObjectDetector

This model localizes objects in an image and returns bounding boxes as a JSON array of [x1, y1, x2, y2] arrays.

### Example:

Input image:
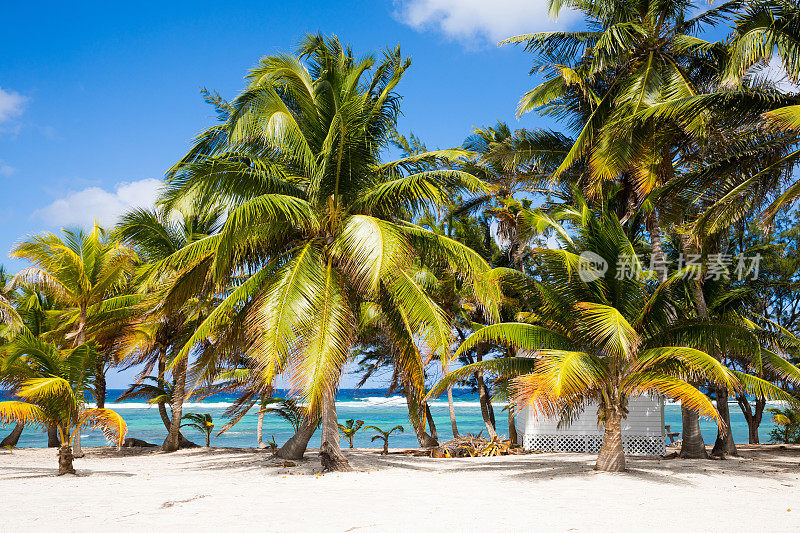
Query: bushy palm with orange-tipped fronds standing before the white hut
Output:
[[430, 206, 788, 471]]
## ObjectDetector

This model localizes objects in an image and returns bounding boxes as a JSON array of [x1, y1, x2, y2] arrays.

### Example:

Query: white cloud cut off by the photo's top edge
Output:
[[395, 0, 573, 43]]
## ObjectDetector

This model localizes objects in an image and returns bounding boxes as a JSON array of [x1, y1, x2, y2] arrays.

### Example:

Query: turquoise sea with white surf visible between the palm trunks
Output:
[[2, 389, 772, 448]]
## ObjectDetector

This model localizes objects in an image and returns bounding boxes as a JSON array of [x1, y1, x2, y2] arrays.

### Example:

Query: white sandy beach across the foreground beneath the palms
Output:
[[0, 447, 800, 533]]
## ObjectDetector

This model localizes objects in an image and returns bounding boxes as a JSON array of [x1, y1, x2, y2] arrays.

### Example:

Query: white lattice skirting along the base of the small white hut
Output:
[[522, 434, 666, 455]]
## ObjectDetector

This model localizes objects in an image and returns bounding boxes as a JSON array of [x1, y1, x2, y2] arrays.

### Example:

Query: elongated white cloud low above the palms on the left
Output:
[[33, 178, 162, 227]]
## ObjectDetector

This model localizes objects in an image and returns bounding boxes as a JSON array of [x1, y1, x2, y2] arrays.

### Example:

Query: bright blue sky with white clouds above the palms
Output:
[[0, 0, 580, 387]]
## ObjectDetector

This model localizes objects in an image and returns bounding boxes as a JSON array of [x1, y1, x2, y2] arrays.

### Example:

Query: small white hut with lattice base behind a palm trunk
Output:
[[517, 396, 666, 456]]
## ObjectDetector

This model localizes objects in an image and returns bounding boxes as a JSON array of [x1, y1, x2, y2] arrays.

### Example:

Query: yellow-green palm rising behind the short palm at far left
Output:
[[11, 224, 138, 456]]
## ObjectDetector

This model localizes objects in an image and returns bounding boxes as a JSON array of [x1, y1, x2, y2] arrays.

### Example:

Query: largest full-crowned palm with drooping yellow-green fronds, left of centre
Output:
[[162, 35, 496, 469]]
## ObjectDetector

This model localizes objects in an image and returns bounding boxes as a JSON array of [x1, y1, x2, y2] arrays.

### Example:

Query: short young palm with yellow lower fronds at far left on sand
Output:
[[0, 333, 127, 475]]
